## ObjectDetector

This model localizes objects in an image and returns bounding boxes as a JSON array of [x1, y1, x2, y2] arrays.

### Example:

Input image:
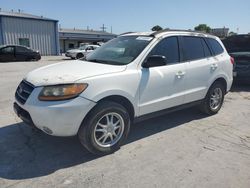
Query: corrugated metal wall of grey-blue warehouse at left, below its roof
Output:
[[2, 17, 59, 55]]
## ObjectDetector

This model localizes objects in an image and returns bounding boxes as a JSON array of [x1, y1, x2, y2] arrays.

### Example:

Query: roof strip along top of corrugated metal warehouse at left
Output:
[[0, 11, 58, 22]]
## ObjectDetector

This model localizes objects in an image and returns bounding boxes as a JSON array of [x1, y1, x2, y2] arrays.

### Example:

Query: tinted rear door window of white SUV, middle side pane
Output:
[[182, 36, 205, 61]]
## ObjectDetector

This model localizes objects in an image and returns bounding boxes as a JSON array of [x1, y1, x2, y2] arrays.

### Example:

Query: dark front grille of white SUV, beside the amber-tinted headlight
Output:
[[15, 80, 34, 104]]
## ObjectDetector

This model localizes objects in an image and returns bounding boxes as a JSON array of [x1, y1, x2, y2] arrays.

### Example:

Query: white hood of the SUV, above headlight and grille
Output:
[[25, 60, 126, 86]]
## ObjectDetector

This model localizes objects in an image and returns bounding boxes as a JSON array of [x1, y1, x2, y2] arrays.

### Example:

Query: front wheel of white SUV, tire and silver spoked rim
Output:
[[78, 101, 130, 155]]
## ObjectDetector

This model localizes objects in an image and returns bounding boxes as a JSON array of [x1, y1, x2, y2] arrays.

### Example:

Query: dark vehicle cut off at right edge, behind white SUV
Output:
[[223, 35, 250, 83]]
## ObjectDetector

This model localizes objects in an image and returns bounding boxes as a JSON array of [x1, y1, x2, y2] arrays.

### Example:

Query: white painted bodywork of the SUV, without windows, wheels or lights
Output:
[[16, 32, 233, 136]]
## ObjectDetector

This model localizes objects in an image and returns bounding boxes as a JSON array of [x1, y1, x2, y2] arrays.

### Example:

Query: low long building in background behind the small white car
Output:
[[59, 28, 116, 53]]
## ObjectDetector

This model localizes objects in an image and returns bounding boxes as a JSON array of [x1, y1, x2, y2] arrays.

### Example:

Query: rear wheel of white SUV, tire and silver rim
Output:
[[200, 82, 226, 115]]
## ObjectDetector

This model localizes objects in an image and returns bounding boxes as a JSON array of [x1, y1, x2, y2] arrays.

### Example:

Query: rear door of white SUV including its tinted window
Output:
[[181, 36, 216, 103]]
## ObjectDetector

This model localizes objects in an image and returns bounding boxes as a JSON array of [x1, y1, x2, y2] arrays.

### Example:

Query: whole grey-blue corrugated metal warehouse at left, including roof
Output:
[[0, 11, 60, 55]]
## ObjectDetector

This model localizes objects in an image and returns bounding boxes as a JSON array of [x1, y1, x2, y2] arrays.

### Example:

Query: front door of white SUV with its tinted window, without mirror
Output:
[[139, 37, 186, 115]]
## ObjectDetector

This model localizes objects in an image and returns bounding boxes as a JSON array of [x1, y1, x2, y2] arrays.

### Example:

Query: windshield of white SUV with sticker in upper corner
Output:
[[86, 36, 153, 65]]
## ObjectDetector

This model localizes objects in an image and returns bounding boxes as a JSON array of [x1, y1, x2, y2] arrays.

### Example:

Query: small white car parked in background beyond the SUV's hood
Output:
[[65, 44, 100, 59]]
